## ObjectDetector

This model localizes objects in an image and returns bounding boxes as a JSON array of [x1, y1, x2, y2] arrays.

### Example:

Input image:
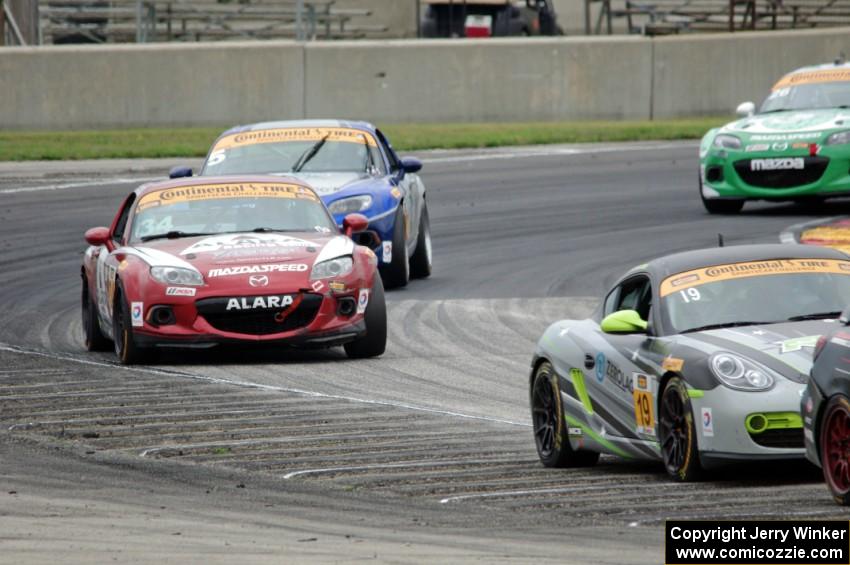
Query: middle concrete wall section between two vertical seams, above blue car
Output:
[[305, 37, 651, 122]]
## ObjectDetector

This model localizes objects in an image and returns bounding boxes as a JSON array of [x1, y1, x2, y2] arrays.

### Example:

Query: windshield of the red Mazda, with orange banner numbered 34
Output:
[[131, 183, 337, 241]]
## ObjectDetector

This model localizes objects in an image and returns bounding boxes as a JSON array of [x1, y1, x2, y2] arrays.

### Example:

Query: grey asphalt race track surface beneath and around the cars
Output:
[[0, 142, 850, 563]]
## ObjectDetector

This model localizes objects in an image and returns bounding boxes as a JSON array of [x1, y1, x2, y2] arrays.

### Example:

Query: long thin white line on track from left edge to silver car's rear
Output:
[[0, 343, 531, 428]]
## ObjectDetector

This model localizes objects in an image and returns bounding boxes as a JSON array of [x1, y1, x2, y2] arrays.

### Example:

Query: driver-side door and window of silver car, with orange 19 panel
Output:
[[585, 274, 656, 444]]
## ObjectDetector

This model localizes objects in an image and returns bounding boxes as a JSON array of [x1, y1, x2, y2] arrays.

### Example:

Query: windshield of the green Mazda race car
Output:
[[759, 67, 850, 113]]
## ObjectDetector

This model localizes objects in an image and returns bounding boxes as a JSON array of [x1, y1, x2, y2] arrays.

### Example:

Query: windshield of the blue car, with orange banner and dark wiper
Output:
[[201, 128, 386, 176]]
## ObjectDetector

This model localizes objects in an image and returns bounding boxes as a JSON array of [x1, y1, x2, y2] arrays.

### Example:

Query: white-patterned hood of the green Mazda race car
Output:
[[720, 109, 850, 142]]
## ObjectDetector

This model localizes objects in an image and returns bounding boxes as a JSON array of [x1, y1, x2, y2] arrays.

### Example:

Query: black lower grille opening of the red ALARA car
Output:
[[195, 293, 322, 335]]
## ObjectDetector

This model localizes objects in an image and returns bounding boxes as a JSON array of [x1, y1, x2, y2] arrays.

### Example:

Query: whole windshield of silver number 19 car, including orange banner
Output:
[[659, 259, 850, 333]]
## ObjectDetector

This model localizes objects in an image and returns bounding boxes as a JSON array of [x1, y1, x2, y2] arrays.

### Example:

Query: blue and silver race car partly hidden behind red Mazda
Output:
[[170, 120, 431, 288]]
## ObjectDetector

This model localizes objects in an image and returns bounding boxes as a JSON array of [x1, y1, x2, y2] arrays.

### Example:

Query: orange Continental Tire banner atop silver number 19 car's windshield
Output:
[[659, 259, 850, 297]]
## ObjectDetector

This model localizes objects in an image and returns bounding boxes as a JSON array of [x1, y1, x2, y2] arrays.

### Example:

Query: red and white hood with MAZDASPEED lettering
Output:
[[124, 232, 354, 285]]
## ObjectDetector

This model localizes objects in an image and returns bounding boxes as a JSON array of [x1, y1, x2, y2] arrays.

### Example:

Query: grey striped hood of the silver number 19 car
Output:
[[677, 320, 836, 382]]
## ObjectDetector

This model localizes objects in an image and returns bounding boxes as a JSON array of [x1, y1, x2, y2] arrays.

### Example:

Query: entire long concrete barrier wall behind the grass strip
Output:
[[0, 28, 850, 129]]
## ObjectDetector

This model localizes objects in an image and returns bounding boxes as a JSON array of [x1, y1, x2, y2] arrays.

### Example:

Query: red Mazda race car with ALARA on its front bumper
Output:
[[81, 176, 387, 364]]
